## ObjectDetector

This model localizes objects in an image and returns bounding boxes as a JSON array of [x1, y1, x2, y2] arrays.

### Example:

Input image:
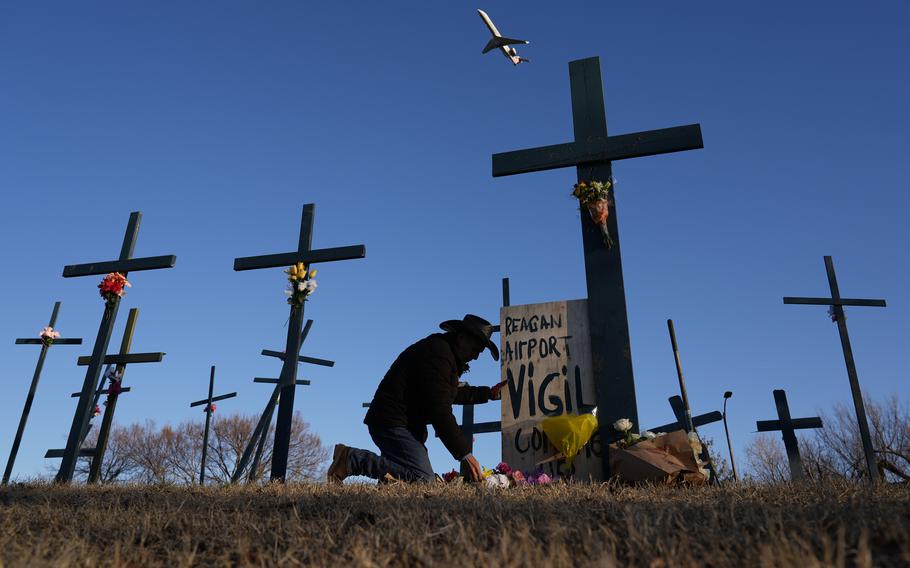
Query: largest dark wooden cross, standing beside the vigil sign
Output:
[[493, 57, 703, 474]]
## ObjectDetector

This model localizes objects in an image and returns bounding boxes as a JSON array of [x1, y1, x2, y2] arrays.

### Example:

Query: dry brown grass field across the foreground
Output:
[[0, 484, 910, 568]]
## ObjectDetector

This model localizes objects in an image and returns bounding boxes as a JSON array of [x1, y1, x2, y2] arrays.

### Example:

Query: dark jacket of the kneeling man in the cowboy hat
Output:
[[363, 333, 490, 459]]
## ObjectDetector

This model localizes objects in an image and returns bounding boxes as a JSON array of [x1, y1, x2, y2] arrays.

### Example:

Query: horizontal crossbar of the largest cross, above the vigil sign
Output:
[[493, 124, 705, 177]]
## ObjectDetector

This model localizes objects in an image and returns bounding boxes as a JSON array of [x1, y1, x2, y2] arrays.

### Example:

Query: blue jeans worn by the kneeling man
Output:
[[348, 427, 436, 482]]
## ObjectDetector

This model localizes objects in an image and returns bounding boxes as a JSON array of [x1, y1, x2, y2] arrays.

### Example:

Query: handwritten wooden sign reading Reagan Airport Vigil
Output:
[[499, 300, 603, 480]]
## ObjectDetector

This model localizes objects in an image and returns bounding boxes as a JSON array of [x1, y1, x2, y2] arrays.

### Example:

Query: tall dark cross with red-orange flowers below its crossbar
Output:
[[56, 211, 177, 483]]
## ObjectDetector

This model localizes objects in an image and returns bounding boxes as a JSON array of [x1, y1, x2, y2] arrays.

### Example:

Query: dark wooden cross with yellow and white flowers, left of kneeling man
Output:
[[234, 203, 366, 481]]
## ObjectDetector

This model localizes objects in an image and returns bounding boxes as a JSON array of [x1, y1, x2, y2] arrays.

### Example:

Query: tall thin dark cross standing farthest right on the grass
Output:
[[784, 256, 885, 485]]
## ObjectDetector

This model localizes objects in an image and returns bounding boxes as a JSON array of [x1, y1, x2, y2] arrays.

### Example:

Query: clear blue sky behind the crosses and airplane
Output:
[[0, 1, 910, 482]]
